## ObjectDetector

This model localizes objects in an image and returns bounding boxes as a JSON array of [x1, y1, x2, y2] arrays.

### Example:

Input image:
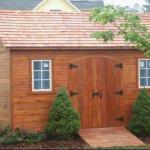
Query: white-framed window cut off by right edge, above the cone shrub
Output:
[[139, 59, 150, 88]]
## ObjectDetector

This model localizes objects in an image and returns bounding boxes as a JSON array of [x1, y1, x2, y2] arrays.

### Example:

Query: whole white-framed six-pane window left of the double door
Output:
[[32, 60, 52, 91]]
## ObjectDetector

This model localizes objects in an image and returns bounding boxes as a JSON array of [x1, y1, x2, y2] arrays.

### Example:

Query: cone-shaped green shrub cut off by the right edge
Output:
[[128, 89, 150, 136]]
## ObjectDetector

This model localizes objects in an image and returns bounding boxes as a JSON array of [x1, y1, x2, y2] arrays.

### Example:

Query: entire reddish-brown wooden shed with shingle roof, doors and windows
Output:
[[0, 11, 150, 129]]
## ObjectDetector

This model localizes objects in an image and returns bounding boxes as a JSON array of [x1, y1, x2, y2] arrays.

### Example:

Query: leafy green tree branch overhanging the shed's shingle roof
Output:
[[90, 6, 150, 56]]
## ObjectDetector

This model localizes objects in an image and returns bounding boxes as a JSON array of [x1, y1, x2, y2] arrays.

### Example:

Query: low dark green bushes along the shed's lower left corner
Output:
[[0, 126, 45, 145]]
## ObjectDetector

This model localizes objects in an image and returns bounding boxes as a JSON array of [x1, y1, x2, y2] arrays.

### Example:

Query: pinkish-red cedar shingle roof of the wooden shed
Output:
[[0, 11, 150, 49]]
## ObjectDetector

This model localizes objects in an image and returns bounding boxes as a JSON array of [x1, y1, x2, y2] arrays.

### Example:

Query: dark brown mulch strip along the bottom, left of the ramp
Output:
[[0, 139, 90, 149]]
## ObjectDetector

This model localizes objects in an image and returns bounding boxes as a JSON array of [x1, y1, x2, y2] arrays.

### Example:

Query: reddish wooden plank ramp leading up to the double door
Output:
[[79, 127, 144, 148]]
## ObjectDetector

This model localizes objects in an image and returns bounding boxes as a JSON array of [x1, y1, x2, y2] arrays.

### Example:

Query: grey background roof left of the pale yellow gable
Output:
[[0, 0, 42, 10]]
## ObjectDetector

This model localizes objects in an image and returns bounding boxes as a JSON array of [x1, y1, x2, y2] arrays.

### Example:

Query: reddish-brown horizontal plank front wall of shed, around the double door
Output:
[[11, 50, 144, 129]]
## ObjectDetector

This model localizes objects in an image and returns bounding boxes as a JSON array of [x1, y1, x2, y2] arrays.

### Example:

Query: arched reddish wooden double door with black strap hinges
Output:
[[69, 57, 123, 128]]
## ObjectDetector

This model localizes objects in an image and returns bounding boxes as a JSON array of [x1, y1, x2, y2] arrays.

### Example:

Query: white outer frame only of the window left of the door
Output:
[[32, 59, 52, 92]]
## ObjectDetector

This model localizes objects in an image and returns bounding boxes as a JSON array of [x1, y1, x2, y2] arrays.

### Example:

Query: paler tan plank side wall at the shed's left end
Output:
[[0, 44, 11, 125]]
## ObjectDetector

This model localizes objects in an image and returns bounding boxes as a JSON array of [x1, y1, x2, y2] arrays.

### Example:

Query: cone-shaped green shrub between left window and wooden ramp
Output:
[[45, 88, 80, 140]]
